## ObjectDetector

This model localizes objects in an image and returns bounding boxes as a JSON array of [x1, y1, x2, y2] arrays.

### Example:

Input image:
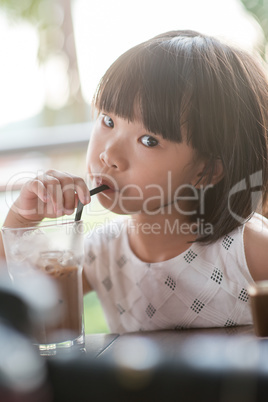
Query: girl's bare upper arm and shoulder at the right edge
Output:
[[244, 214, 268, 281]]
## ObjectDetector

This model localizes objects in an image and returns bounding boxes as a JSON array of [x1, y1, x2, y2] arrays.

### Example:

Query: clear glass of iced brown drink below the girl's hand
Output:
[[2, 220, 85, 356]]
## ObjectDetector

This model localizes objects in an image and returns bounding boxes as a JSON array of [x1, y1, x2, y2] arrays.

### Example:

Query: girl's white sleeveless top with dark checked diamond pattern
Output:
[[85, 214, 268, 333]]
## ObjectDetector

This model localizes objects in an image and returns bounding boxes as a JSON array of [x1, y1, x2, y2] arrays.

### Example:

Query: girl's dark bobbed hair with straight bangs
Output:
[[93, 31, 268, 242]]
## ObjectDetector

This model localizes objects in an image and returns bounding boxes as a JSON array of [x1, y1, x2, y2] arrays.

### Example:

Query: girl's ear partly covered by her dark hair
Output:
[[195, 158, 224, 188]]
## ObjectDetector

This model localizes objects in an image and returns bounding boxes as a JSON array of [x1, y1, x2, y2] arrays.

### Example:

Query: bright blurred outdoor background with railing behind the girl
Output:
[[0, 0, 268, 333]]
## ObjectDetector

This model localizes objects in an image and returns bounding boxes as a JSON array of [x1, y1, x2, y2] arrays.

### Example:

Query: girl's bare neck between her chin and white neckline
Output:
[[128, 213, 197, 263]]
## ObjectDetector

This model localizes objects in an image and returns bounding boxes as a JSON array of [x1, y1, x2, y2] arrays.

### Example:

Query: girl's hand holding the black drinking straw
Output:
[[12, 170, 90, 221]]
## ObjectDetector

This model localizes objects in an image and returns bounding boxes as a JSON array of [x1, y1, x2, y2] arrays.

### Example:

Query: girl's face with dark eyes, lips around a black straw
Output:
[[87, 113, 205, 215]]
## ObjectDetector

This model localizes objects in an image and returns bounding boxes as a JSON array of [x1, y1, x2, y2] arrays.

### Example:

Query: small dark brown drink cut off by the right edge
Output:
[[249, 281, 268, 336]]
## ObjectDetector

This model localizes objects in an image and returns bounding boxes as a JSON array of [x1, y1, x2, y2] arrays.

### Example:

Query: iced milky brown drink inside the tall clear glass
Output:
[[36, 251, 83, 344]]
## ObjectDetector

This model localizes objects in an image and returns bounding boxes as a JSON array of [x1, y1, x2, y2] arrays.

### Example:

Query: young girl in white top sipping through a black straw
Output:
[[1, 31, 268, 332]]
